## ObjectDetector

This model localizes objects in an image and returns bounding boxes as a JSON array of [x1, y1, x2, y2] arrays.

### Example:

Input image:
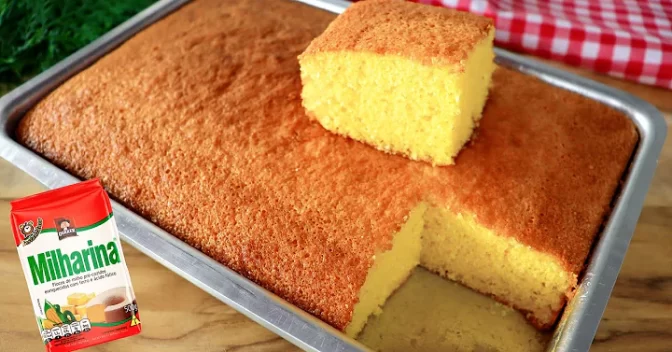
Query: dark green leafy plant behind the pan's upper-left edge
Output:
[[0, 0, 155, 85]]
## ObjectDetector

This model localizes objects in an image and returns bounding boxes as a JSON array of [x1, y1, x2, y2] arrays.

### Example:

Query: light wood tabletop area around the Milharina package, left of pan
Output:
[[0, 163, 299, 352]]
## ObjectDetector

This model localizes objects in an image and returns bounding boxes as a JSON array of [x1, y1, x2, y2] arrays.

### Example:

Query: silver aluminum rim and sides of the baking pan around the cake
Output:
[[0, 0, 666, 351]]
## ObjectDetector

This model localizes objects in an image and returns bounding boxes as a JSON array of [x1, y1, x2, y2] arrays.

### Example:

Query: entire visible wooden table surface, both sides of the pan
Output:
[[0, 65, 672, 352]]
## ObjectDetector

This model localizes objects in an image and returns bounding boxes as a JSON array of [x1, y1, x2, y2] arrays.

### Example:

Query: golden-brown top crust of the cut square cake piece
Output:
[[302, 0, 494, 71]]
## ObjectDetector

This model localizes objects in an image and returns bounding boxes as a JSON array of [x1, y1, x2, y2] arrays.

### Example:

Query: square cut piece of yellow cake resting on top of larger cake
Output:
[[299, 0, 495, 165]]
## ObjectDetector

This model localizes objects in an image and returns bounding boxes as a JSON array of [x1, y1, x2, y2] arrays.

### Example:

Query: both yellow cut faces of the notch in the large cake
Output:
[[345, 198, 577, 338]]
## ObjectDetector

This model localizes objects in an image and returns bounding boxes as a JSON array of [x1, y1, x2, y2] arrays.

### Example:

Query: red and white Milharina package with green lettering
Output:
[[11, 180, 140, 352]]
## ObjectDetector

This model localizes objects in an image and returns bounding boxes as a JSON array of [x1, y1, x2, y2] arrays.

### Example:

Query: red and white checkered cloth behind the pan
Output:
[[413, 0, 672, 89]]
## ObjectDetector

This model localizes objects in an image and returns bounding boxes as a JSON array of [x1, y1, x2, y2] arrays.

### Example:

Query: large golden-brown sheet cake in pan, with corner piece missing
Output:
[[16, 0, 637, 336]]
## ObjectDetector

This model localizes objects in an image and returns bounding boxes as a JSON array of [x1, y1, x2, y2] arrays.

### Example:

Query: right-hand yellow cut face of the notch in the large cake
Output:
[[420, 207, 578, 330]]
